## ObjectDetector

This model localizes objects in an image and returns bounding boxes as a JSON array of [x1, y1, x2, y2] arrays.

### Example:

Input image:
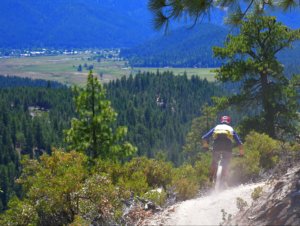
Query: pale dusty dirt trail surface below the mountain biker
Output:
[[145, 183, 263, 225]]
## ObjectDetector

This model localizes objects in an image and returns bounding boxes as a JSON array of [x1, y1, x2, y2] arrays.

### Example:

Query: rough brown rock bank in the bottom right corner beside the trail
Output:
[[224, 166, 300, 226]]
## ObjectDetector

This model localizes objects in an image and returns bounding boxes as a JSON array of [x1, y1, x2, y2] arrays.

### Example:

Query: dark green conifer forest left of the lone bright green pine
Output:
[[0, 76, 74, 212]]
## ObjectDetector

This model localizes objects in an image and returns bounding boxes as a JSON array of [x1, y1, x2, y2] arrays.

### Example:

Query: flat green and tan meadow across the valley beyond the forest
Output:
[[0, 54, 214, 85]]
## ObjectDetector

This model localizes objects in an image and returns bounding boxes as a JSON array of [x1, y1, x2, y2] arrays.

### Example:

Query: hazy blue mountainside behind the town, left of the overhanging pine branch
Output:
[[0, 0, 155, 48]]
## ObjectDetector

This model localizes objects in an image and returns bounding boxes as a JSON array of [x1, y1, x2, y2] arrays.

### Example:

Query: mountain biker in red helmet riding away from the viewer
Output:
[[202, 116, 244, 185]]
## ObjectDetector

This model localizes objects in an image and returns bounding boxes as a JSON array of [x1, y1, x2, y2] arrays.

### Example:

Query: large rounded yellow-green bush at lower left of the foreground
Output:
[[18, 150, 87, 225]]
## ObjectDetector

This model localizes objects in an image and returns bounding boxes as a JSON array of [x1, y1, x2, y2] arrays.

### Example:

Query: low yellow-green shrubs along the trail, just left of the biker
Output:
[[95, 155, 202, 202]]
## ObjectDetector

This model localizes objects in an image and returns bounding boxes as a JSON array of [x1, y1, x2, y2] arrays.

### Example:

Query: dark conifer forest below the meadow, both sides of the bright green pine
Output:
[[0, 72, 220, 209]]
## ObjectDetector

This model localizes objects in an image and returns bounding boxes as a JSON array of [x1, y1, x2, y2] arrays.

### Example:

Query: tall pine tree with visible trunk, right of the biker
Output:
[[213, 15, 300, 138]]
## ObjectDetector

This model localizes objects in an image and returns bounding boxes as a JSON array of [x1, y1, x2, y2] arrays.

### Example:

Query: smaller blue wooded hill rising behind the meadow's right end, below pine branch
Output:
[[121, 24, 228, 67]]
